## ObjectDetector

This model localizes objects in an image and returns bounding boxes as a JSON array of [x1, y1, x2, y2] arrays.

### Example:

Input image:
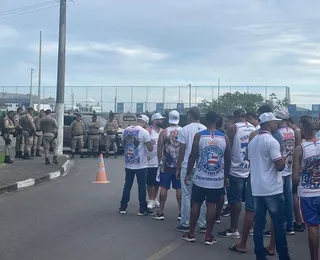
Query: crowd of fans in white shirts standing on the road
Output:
[[119, 105, 320, 260]]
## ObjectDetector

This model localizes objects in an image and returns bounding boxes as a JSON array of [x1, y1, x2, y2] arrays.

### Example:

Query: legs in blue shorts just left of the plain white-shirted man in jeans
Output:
[[218, 176, 247, 238]]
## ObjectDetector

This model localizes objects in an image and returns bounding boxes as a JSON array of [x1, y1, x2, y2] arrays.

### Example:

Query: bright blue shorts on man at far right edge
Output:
[[300, 197, 320, 226]]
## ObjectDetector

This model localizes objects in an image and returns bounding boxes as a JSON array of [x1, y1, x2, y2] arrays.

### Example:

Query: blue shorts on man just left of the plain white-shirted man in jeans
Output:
[[227, 175, 248, 204]]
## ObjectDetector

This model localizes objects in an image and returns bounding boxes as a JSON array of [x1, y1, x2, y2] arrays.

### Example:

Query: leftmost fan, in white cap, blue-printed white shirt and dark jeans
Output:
[[119, 115, 153, 216]]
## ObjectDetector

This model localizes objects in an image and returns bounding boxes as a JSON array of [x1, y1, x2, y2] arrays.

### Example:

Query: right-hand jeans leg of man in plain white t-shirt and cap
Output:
[[265, 194, 290, 260]]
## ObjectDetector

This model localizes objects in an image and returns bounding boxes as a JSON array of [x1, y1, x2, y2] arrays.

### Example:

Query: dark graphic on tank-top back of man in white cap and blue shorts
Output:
[[164, 129, 179, 168]]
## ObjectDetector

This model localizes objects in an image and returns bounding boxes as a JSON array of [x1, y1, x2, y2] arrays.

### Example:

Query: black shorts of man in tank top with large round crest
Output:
[[191, 184, 225, 204]]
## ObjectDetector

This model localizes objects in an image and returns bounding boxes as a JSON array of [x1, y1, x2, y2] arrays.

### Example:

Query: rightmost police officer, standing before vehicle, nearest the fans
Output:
[[104, 111, 119, 158]]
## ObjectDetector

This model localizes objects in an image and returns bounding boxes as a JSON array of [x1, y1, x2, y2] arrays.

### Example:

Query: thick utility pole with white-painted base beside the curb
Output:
[[56, 0, 67, 154]]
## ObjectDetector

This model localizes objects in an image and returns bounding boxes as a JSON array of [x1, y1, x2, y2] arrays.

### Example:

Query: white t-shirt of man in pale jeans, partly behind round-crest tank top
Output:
[[178, 123, 207, 168]]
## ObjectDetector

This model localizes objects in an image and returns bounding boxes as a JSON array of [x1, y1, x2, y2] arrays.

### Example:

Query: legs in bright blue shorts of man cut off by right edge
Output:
[[300, 197, 320, 260]]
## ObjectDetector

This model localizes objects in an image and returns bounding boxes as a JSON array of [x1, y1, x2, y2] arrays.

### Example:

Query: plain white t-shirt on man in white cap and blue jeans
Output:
[[248, 131, 283, 196]]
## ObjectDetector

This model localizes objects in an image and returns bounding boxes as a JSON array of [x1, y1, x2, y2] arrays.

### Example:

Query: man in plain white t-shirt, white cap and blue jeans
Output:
[[248, 113, 290, 260]]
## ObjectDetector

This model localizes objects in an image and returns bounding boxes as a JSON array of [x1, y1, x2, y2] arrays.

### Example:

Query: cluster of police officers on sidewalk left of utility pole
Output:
[[2, 107, 59, 164]]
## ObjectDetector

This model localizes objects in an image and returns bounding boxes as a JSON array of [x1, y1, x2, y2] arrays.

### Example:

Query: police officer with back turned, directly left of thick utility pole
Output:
[[39, 109, 59, 165]]
